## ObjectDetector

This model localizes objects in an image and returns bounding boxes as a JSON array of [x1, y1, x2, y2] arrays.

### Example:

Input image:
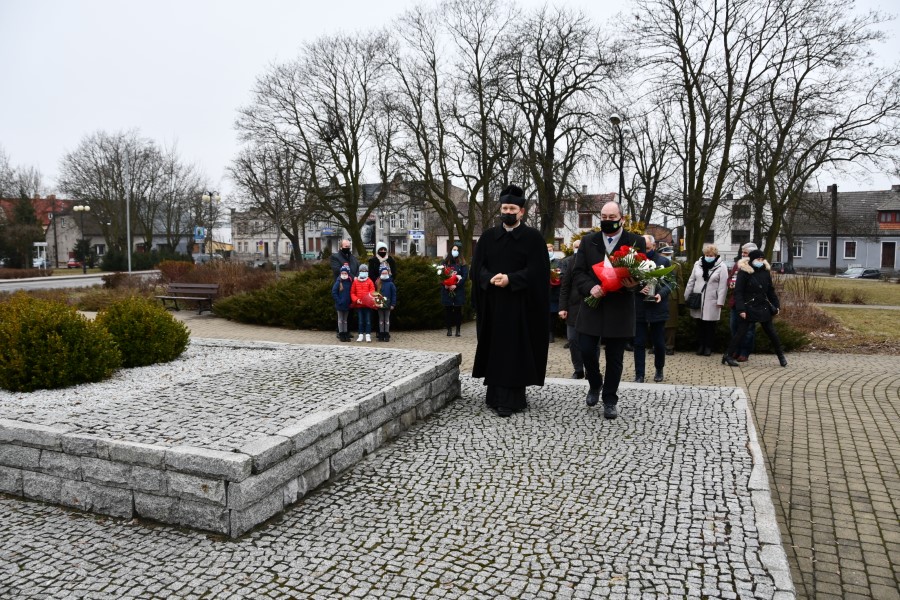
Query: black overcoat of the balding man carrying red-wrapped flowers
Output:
[[572, 231, 647, 338]]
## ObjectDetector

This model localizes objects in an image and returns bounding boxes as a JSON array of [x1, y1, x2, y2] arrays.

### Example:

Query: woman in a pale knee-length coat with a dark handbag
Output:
[[684, 244, 728, 356]]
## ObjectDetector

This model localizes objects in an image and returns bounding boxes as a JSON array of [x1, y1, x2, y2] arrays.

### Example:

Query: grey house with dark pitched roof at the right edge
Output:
[[792, 185, 900, 274]]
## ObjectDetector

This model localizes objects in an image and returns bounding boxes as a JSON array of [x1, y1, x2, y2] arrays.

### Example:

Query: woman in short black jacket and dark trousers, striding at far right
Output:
[[722, 250, 787, 367]]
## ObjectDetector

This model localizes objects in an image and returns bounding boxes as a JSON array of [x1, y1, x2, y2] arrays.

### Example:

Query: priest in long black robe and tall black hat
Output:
[[470, 185, 550, 417]]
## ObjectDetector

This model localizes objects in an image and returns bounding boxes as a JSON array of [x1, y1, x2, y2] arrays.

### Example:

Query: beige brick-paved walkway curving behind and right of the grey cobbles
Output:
[[180, 312, 900, 600]]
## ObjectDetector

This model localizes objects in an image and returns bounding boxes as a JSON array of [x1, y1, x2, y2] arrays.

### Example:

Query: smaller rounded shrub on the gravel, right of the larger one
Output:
[[97, 297, 190, 367]]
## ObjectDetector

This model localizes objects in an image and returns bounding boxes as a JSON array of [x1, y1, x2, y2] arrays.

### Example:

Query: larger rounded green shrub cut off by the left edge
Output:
[[0, 294, 121, 392]]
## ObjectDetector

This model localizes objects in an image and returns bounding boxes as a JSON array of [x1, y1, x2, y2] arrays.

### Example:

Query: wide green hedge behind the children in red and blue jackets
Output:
[[213, 257, 458, 331]]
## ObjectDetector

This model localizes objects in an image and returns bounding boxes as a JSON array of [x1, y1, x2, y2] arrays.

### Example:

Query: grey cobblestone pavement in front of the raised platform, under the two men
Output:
[[0, 377, 783, 599]]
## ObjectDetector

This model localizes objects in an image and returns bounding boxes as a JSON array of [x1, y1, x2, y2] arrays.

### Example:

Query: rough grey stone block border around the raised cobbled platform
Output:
[[0, 354, 461, 537]]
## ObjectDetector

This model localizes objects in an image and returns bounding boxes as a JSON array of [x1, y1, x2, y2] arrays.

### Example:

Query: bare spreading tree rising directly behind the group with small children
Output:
[[237, 33, 397, 255]]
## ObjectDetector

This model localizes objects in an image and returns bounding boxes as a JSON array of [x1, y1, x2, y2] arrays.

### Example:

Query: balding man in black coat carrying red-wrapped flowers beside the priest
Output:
[[573, 202, 647, 419]]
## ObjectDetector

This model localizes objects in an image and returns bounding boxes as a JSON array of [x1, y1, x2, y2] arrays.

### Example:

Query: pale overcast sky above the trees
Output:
[[0, 0, 900, 201]]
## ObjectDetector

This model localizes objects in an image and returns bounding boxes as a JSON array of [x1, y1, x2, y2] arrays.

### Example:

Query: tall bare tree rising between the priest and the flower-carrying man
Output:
[[501, 7, 616, 240]]
